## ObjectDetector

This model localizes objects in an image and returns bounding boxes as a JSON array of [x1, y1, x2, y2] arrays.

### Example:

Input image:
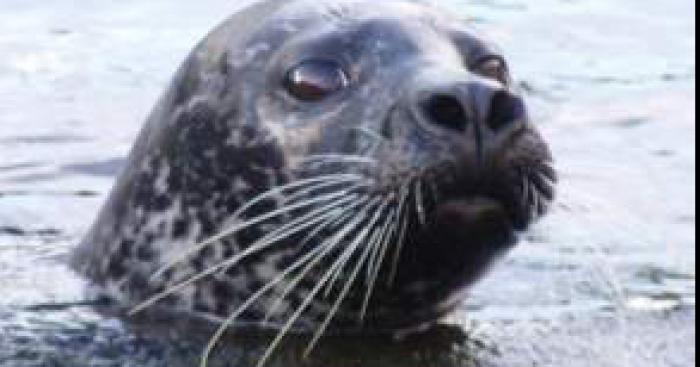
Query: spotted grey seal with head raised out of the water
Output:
[[73, 0, 557, 364]]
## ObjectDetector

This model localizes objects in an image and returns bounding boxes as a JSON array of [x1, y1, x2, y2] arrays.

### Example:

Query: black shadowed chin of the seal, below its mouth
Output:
[[360, 198, 517, 331]]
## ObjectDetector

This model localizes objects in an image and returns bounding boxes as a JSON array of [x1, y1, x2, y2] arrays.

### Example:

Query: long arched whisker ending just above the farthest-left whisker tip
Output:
[[151, 180, 369, 279]]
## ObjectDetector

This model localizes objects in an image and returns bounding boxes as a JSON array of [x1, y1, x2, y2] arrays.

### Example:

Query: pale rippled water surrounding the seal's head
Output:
[[0, 0, 696, 367]]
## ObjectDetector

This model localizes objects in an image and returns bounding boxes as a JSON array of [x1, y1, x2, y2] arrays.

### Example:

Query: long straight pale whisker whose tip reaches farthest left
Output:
[[130, 195, 364, 315]]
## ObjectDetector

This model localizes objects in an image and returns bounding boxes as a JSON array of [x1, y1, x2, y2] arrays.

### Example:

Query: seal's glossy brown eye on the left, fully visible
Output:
[[284, 60, 349, 102]]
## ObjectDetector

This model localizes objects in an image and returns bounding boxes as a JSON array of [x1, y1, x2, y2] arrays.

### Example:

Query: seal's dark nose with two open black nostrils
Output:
[[421, 80, 525, 133]]
